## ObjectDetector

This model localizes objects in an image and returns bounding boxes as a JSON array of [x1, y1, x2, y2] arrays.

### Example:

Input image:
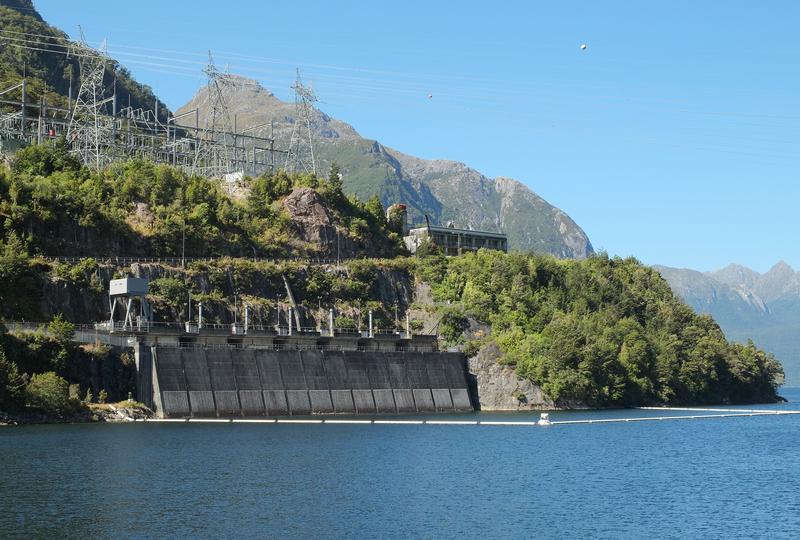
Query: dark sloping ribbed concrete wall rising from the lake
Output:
[[148, 346, 473, 418]]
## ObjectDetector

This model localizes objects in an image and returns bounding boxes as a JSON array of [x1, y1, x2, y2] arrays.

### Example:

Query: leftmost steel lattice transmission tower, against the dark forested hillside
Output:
[[67, 31, 114, 170]]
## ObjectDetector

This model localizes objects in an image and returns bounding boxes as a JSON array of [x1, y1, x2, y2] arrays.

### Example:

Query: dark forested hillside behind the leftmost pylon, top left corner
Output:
[[0, 0, 169, 120]]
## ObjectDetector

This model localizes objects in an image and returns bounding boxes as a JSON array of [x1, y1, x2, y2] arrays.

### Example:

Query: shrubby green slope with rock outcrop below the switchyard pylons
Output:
[[0, 140, 403, 258]]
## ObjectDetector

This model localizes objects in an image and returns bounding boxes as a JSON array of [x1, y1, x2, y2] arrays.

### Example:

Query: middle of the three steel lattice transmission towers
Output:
[[194, 51, 236, 177]]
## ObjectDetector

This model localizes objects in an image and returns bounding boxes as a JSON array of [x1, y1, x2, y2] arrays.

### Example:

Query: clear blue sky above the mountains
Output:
[[35, 0, 800, 271]]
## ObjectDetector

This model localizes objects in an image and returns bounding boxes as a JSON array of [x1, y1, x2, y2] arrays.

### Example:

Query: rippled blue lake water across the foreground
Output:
[[0, 389, 800, 538]]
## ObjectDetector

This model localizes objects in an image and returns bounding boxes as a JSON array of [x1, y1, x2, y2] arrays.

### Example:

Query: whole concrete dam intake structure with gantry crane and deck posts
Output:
[[75, 278, 477, 418]]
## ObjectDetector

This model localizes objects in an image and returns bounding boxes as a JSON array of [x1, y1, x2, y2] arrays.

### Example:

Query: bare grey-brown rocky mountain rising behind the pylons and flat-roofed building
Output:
[[178, 78, 593, 258]]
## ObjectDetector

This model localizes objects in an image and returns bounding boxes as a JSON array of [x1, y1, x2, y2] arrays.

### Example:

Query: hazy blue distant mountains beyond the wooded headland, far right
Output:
[[655, 261, 800, 386]]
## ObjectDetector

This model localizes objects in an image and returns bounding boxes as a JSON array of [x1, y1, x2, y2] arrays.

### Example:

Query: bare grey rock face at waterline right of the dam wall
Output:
[[469, 343, 557, 411]]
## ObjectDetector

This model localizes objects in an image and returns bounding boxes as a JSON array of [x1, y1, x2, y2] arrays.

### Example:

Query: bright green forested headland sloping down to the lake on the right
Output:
[[418, 251, 783, 406]]
